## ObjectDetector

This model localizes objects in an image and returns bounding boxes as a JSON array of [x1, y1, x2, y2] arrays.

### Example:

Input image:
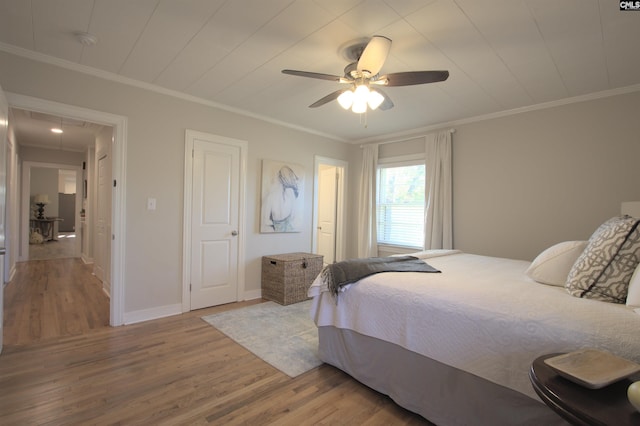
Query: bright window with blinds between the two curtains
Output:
[[376, 160, 425, 248]]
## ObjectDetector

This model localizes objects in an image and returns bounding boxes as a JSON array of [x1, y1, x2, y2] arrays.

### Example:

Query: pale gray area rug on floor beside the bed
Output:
[[202, 300, 322, 377]]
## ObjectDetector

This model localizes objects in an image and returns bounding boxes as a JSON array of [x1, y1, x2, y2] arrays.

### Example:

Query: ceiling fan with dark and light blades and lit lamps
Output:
[[282, 35, 449, 114]]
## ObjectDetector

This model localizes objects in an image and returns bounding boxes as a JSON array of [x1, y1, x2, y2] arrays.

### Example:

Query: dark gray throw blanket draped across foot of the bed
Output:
[[321, 256, 440, 297]]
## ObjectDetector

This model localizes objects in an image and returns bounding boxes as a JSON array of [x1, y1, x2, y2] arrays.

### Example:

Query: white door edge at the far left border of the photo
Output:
[[0, 88, 9, 352]]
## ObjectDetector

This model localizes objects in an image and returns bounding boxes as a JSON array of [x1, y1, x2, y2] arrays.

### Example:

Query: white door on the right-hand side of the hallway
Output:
[[93, 153, 111, 294]]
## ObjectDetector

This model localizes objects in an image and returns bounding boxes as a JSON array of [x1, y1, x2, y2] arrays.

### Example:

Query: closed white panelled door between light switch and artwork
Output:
[[190, 137, 241, 310]]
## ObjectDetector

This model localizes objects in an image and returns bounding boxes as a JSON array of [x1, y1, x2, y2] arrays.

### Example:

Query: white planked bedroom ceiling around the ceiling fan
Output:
[[0, 0, 640, 141]]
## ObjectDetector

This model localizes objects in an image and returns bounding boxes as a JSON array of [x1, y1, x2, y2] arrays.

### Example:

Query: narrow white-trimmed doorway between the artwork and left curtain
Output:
[[313, 156, 347, 264]]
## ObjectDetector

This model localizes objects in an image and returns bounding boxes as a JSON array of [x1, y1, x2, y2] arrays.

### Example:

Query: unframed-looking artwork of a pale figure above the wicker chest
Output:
[[260, 160, 305, 233]]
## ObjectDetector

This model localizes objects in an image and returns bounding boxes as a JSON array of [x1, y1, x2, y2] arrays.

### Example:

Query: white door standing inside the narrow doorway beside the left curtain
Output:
[[316, 165, 338, 263]]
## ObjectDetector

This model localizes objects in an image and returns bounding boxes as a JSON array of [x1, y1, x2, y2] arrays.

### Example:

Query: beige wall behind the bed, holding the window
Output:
[[356, 92, 640, 260]]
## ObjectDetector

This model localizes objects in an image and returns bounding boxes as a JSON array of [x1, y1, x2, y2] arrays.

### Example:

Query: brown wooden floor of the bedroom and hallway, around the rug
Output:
[[0, 261, 429, 425]]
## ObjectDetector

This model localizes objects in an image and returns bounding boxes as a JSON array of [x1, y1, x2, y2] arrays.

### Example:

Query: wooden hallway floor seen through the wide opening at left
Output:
[[4, 256, 109, 346]]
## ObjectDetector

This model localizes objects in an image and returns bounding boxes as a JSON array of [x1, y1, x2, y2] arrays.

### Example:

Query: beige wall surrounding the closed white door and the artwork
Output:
[[0, 53, 352, 313]]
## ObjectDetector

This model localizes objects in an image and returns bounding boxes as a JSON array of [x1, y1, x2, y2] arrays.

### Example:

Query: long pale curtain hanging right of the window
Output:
[[424, 130, 453, 250]]
